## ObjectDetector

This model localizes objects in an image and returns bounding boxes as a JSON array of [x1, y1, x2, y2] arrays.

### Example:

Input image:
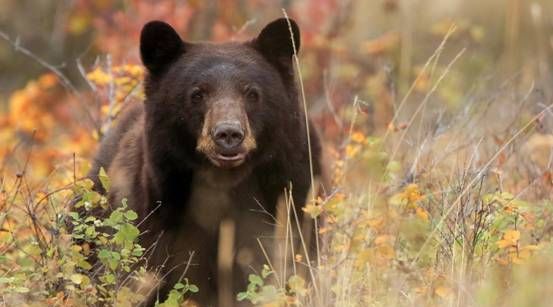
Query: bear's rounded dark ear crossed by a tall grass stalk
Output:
[[253, 18, 300, 69]]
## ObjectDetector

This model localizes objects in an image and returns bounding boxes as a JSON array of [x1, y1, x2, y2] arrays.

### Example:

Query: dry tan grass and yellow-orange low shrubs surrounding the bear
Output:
[[0, 1, 553, 306]]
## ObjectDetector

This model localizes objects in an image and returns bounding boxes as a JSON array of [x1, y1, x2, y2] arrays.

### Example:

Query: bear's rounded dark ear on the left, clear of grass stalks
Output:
[[140, 20, 185, 74]]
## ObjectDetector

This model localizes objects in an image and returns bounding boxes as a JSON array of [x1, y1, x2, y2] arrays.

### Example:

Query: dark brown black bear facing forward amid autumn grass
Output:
[[90, 19, 321, 305]]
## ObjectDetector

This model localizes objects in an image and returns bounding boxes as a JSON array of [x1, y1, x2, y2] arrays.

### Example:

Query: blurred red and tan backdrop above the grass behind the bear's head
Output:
[[0, 0, 553, 129]]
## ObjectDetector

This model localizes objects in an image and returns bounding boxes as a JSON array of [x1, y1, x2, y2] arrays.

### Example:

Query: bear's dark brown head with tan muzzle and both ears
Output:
[[140, 18, 301, 173]]
